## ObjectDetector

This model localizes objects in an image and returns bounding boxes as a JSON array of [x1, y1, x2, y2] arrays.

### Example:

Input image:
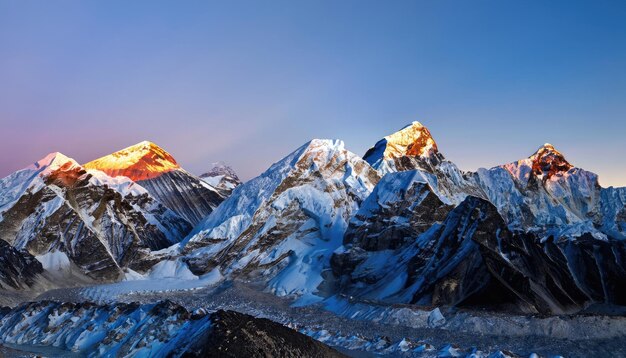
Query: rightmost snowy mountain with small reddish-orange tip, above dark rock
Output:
[[474, 144, 626, 240]]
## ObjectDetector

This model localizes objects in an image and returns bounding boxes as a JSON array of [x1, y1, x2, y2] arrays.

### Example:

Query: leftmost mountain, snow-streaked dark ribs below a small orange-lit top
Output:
[[0, 153, 191, 280]]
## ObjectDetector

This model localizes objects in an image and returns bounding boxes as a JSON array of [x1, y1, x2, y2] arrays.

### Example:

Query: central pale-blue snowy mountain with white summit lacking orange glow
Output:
[[184, 140, 379, 295]]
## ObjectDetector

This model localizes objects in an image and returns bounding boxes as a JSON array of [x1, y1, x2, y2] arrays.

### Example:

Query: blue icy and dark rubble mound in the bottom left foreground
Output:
[[0, 301, 342, 357]]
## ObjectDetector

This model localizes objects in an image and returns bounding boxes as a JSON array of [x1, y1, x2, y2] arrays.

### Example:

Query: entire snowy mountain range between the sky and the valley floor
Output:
[[0, 122, 626, 314]]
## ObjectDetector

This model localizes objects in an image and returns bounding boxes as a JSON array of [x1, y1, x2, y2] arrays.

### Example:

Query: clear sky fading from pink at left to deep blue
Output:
[[0, 0, 626, 186]]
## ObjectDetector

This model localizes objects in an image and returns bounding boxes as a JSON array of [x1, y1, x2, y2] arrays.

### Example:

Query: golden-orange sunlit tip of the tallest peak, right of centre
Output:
[[363, 122, 438, 164]]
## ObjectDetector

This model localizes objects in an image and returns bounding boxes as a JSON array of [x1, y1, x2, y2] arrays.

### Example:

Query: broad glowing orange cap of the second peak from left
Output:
[[85, 141, 180, 181]]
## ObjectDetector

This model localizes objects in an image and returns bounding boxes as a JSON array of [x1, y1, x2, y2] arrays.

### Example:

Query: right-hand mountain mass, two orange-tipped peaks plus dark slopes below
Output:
[[331, 123, 626, 313]]
